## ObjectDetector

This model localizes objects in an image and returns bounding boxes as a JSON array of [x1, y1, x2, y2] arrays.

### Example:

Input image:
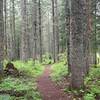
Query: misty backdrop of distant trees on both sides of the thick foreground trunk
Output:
[[1, 0, 100, 63]]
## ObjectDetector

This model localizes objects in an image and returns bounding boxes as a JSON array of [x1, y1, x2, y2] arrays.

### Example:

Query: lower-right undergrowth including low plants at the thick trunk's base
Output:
[[64, 65, 100, 100]]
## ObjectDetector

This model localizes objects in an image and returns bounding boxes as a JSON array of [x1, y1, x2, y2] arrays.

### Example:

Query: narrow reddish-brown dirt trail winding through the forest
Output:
[[38, 66, 71, 100]]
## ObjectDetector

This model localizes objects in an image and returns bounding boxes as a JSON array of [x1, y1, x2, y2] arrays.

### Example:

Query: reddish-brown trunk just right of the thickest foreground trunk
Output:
[[83, 0, 92, 75]]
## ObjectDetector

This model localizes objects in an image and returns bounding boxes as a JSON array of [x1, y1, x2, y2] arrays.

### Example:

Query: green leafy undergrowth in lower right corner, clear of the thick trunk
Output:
[[84, 65, 100, 100]]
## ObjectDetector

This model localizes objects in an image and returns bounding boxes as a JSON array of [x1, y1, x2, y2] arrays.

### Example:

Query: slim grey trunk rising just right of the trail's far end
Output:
[[52, 0, 59, 62]]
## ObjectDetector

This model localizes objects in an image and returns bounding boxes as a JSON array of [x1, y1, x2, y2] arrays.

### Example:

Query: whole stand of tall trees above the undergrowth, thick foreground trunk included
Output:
[[0, 0, 100, 88]]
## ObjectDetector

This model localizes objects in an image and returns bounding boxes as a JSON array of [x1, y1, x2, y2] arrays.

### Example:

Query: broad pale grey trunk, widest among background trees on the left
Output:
[[20, 0, 28, 61]]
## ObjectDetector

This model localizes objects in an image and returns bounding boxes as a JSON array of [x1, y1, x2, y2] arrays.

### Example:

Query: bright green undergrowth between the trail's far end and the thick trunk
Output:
[[51, 53, 68, 82]]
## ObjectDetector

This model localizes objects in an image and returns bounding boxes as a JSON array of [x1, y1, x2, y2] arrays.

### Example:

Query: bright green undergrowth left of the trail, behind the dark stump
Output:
[[4, 60, 44, 77]]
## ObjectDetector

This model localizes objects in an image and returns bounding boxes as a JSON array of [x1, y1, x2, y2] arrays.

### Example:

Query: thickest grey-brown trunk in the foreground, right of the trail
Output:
[[70, 0, 87, 89]]
